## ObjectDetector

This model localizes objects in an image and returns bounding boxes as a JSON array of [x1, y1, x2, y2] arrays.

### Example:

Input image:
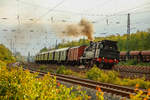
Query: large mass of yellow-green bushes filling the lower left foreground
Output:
[[0, 67, 88, 100]]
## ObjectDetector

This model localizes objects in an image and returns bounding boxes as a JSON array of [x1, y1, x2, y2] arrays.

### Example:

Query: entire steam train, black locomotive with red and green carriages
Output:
[[35, 40, 120, 69]]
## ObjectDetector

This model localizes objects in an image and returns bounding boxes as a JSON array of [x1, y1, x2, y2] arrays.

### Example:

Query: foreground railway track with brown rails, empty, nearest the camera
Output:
[[24, 68, 147, 98]]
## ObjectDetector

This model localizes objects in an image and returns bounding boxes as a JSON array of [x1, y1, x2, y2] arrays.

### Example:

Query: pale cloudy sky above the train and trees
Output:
[[0, 0, 150, 55]]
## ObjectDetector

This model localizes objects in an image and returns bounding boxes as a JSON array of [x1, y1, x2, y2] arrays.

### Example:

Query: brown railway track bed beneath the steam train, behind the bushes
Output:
[[25, 64, 150, 81]]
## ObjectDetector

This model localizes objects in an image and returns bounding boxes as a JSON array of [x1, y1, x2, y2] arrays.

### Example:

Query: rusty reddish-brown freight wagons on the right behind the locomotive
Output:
[[119, 51, 150, 62]]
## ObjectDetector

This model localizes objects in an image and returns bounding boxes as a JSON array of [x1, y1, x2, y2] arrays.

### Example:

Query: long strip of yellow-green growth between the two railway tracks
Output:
[[28, 65, 150, 89]]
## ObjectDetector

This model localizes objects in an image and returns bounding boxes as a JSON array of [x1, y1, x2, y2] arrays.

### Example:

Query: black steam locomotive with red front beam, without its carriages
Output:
[[81, 40, 119, 68]]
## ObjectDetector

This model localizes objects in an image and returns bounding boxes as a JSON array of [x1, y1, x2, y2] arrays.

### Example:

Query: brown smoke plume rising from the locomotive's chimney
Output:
[[56, 19, 94, 41]]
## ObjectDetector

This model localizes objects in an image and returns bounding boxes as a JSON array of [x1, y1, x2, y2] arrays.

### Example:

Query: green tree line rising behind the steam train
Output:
[[40, 29, 150, 52]]
